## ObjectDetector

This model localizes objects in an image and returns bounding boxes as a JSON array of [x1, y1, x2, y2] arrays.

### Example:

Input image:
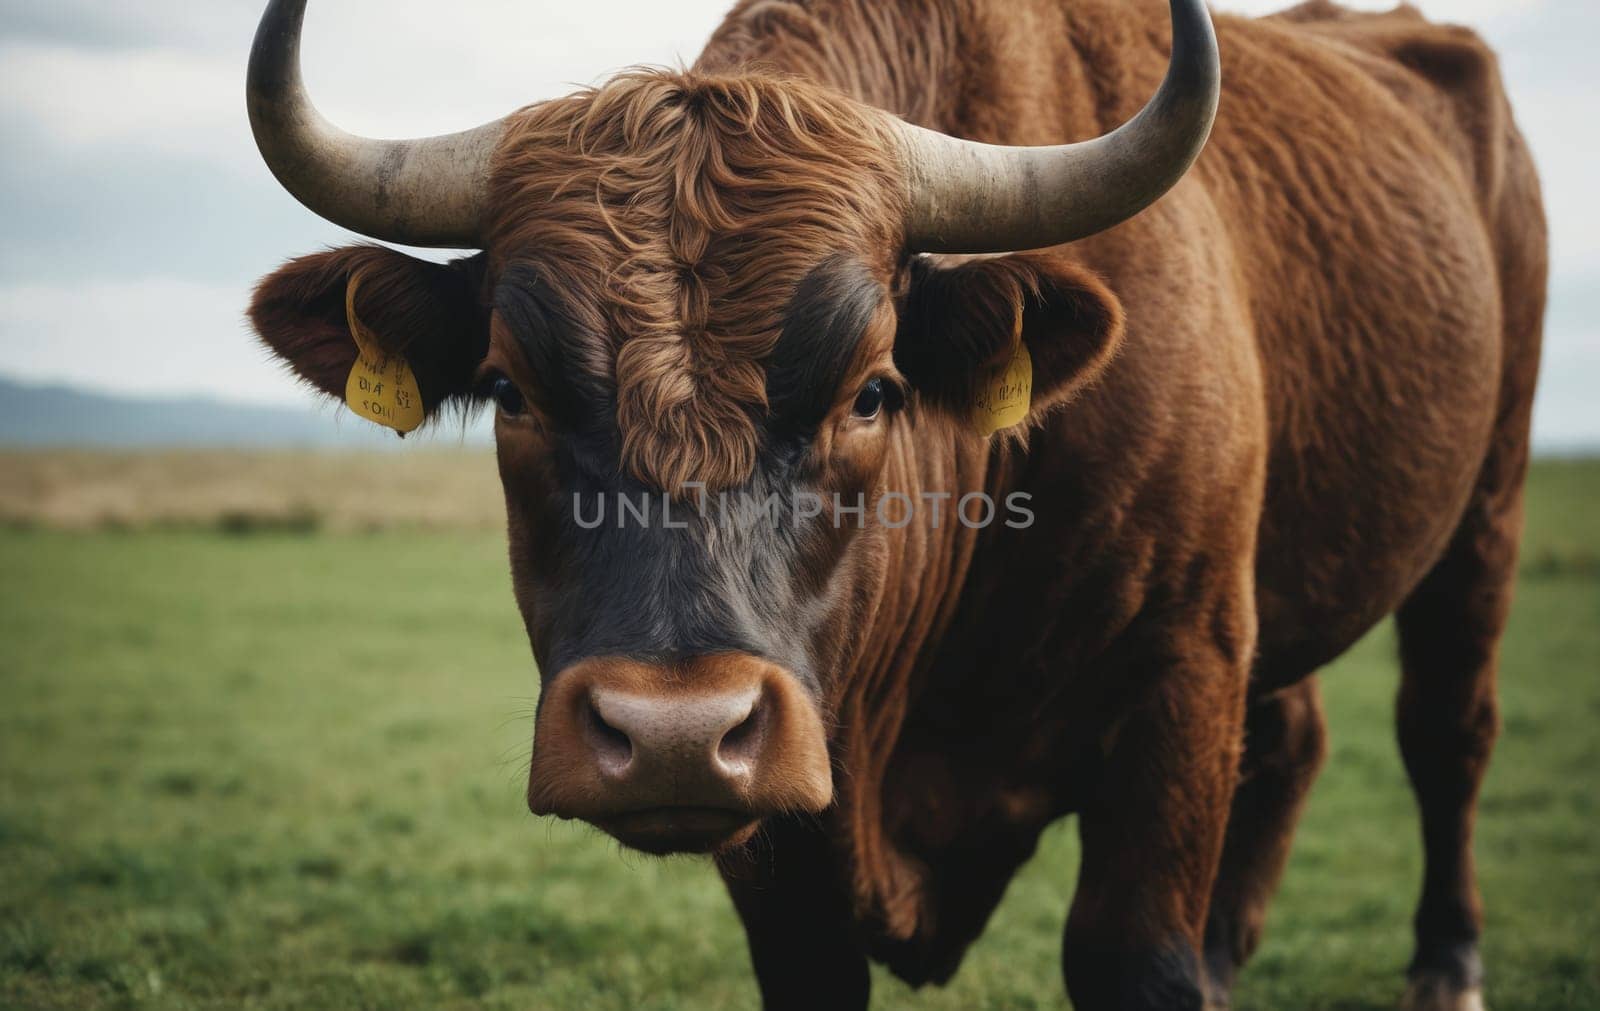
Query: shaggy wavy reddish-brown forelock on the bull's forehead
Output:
[[490, 70, 904, 493]]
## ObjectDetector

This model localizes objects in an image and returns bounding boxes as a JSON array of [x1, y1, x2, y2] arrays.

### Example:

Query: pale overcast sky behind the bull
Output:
[[0, 0, 1600, 448]]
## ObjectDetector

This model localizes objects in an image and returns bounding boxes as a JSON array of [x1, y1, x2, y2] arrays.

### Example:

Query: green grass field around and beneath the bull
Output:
[[0, 461, 1600, 1011]]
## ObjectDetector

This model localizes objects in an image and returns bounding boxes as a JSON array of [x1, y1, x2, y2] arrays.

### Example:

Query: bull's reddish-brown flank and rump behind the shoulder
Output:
[[1200, 3, 1542, 683]]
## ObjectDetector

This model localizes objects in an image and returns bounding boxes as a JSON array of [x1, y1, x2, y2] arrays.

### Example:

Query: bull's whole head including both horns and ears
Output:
[[250, 0, 1218, 851]]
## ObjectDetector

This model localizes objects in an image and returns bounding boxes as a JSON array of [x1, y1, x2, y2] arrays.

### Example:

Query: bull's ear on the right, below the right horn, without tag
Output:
[[894, 253, 1123, 421]]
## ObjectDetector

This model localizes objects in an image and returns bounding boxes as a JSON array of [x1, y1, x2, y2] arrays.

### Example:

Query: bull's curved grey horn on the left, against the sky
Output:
[[245, 0, 504, 248]]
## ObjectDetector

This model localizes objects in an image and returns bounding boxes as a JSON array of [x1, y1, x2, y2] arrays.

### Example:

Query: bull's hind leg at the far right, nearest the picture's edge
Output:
[[1397, 488, 1522, 1011]]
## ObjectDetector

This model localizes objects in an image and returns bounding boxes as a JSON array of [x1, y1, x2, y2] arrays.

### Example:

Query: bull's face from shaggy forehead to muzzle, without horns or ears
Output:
[[482, 88, 904, 851]]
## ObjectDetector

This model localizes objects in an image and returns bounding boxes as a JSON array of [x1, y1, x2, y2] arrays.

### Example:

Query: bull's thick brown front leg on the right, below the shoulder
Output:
[[1062, 637, 1250, 1011]]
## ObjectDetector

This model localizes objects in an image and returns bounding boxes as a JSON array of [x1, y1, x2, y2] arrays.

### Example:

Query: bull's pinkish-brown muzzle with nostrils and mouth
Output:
[[528, 653, 834, 853]]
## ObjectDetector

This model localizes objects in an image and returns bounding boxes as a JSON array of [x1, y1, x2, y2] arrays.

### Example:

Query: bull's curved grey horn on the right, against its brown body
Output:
[[891, 0, 1221, 253]]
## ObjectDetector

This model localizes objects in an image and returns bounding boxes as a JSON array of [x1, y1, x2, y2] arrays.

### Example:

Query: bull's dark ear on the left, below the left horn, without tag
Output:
[[250, 245, 490, 414]]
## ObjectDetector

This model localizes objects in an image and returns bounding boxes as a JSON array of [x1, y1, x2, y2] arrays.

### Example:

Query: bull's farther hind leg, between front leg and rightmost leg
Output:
[[1205, 677, 1326, 1008]]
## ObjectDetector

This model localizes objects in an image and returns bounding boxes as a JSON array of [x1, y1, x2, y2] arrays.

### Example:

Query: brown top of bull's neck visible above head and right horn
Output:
[[694, 0, 1168, 144]]
